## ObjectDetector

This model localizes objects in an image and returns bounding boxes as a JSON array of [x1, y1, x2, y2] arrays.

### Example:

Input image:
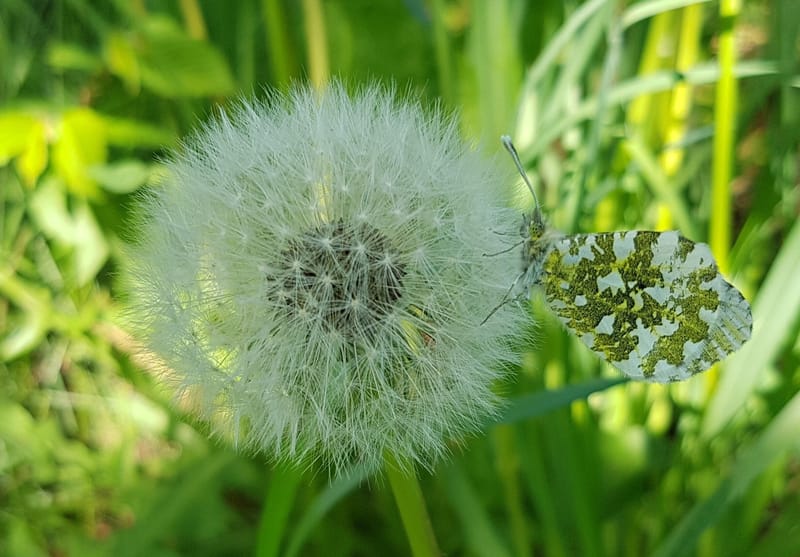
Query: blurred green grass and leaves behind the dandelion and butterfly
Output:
[[0, 0, 800, 557]]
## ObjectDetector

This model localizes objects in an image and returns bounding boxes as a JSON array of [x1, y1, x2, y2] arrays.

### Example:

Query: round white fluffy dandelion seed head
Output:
[[125, 84, 523, 473]]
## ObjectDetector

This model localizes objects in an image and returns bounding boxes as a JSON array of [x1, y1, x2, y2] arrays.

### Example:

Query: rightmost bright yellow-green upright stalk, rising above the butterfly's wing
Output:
[[708, 0, 740, 273]]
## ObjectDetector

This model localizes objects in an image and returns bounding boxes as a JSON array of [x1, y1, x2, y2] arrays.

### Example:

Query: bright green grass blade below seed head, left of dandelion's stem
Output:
[[256, 466, 303, 557]]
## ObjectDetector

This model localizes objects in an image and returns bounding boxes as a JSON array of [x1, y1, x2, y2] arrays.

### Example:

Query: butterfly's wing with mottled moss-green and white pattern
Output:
[[538, 231, 752, 383]]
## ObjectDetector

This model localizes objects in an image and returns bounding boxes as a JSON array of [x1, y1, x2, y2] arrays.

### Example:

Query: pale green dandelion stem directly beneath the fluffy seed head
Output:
[[386, 456, 441, 557]]
